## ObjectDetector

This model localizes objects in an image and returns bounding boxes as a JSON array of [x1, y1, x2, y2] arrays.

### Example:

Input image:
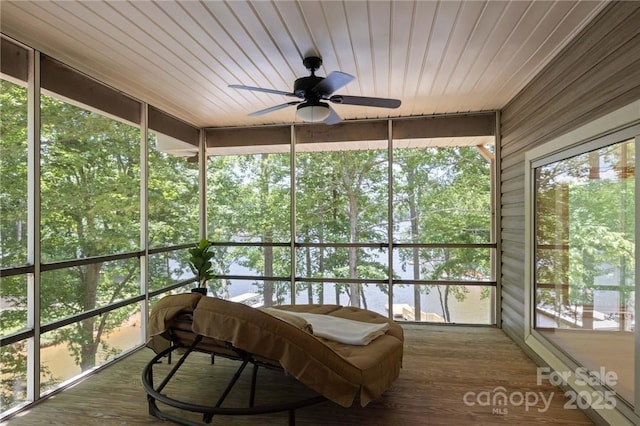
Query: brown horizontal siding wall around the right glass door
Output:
[[500, 2, 640, 346]]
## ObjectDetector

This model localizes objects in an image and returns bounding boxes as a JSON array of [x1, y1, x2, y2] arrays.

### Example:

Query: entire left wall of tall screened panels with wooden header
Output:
[[0, 40, 208, 416]]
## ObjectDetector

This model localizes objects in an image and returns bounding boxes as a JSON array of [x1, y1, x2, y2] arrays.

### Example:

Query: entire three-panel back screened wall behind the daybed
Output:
[[207, 114, 496, 324]]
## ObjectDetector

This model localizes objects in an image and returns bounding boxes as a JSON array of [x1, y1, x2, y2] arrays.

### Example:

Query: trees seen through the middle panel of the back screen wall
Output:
[[296, 150, 387, 307]]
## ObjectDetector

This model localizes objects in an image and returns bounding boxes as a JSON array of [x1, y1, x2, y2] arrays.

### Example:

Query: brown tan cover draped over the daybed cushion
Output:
[[147, 293, 404, 407]]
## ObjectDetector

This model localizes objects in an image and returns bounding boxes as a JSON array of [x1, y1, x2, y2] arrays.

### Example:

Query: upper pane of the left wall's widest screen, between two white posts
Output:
[[40, 95, 140, 262]]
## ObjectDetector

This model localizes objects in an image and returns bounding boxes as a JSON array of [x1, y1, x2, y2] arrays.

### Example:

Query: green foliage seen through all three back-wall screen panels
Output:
[[207, 147, 491, 316]]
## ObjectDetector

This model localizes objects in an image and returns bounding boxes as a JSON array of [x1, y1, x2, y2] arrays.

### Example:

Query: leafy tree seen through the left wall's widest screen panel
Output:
[[40, 96, 140, 370]]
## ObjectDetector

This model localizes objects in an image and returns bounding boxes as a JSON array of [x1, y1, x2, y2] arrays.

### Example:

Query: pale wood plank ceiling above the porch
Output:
[[0, 0, 605, 127]]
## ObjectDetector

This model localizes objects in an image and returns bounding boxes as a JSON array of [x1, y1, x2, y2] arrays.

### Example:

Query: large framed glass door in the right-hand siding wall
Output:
[[527, 99, 640, 421]]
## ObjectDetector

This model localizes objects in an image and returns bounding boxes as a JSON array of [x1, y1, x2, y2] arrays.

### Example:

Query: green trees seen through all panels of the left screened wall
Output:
[[0, 85, 198, 405]]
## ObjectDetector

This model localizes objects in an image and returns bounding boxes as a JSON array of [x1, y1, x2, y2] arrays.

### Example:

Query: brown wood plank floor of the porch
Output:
[[4, 325, 592, 426]]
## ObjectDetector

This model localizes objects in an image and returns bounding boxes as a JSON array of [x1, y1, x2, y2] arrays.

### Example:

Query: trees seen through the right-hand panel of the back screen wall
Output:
[[394, 147, 491, 322]]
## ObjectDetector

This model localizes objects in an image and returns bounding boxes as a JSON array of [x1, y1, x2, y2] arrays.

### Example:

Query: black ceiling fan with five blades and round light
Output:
[[229, 56, 400, 124]]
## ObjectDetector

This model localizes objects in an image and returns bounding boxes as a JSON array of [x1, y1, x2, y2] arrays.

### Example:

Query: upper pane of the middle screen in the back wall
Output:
[[296, 146, 388, 243]]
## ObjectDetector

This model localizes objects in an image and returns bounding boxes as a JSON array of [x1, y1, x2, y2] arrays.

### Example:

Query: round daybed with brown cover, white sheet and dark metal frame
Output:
[[142, 293, 404, 424]]
